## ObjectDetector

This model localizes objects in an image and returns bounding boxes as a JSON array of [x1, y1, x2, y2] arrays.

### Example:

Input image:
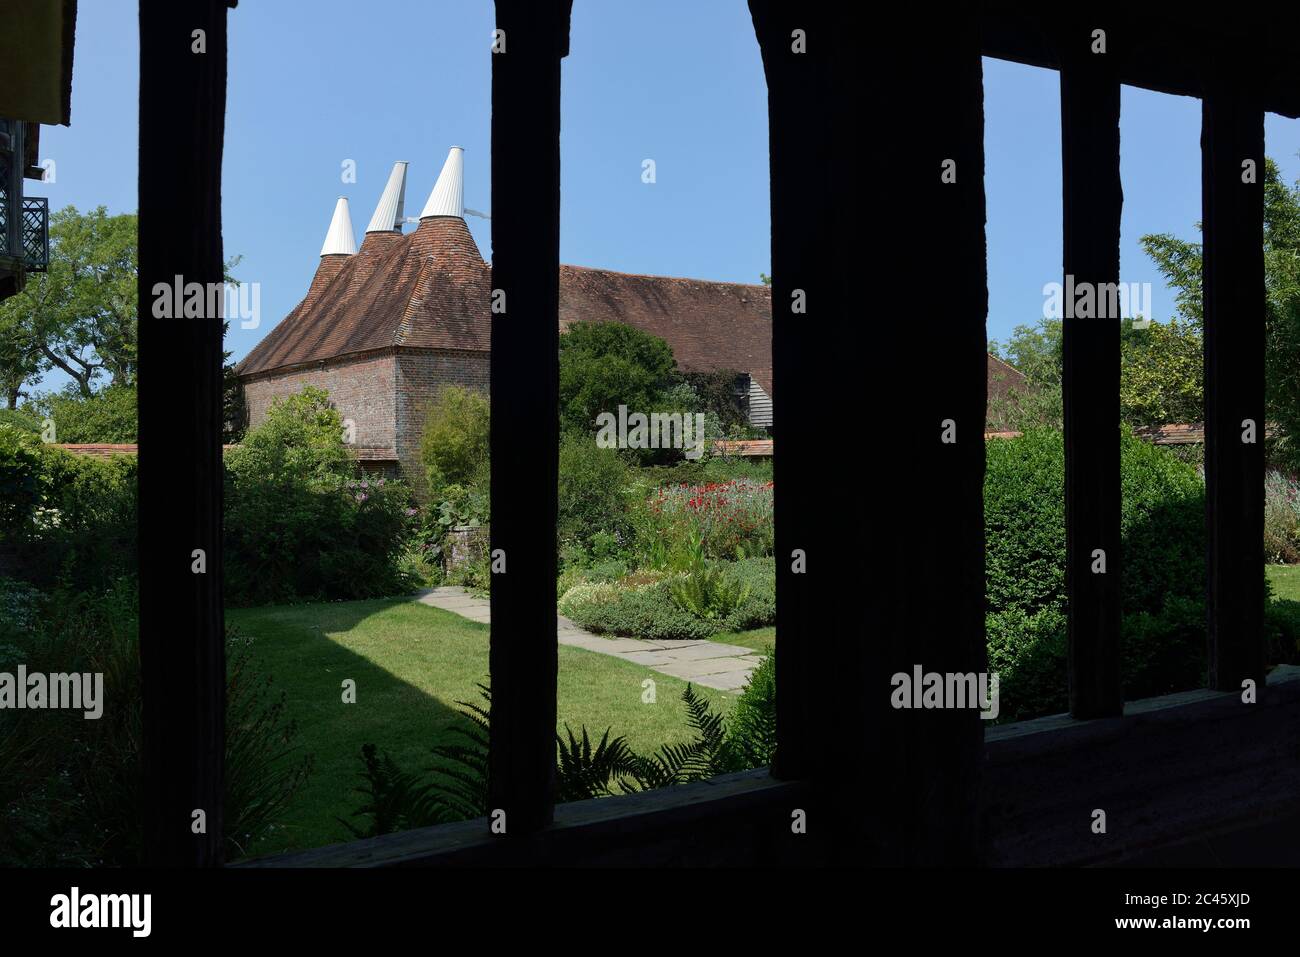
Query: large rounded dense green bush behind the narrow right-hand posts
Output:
[[984, 430, 1205, 719]]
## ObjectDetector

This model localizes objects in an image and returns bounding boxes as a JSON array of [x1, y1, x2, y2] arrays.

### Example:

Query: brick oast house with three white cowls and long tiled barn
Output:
[[238, 147, 1019, 494]]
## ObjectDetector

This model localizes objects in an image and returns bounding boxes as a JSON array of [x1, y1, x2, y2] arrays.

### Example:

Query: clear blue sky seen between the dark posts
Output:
[[27, 0, 1300, 387]]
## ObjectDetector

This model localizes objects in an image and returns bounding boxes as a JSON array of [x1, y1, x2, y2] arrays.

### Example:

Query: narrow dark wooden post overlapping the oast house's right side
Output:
[[489, 0, 571, 835]]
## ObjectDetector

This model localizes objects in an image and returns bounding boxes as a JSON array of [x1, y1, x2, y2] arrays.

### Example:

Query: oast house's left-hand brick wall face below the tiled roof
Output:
[[244, 352, 398, 449]]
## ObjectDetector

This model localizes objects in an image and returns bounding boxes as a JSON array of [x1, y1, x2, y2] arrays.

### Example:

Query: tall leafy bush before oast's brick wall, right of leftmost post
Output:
[[225, 389, 412, 605]]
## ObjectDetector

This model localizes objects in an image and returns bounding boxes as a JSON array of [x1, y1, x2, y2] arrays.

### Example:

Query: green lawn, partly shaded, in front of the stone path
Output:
[[226, 598, 748, 856]]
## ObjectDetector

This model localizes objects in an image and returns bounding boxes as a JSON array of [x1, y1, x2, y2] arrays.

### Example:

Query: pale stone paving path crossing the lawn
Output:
[[416, 585, 763, 692]]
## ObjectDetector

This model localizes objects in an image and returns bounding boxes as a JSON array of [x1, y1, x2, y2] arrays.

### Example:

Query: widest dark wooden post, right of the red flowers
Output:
[[750, 0, 987, 863]]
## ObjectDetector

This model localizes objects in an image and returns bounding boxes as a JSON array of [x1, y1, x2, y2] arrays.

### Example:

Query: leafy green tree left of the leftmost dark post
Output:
[[0, 205, 138, 408]]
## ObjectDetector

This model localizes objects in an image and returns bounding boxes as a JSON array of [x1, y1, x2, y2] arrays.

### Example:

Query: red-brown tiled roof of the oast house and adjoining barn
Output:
[[239, 216, 772, 395]]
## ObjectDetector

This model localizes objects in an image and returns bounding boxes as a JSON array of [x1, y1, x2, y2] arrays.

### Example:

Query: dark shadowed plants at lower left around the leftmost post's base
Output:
[[0, 577, 311, 867]]
